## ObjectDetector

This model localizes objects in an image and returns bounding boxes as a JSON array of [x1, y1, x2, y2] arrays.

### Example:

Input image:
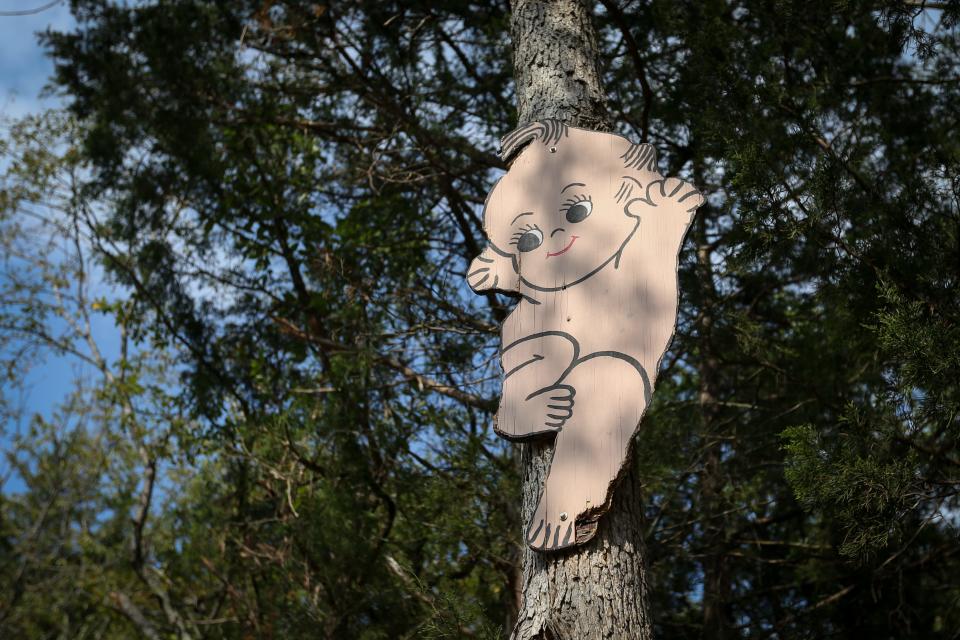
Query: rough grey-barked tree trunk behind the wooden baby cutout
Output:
[[511, 0, 652, 640]]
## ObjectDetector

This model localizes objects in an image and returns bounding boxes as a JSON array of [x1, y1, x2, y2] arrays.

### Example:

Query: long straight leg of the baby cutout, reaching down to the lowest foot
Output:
[[526, 355, 650, 551]]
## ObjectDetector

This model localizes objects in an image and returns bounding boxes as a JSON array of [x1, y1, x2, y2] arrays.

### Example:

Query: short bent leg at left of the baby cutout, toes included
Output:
[[495, 332, 578, 440]]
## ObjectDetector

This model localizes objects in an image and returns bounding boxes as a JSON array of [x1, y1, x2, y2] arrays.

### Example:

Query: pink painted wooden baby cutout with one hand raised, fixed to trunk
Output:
[[467, 120, 703, 551]]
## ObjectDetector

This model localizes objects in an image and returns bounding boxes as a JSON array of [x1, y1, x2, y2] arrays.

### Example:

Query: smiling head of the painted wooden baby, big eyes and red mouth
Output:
[[476, 129, 654, 291]]
